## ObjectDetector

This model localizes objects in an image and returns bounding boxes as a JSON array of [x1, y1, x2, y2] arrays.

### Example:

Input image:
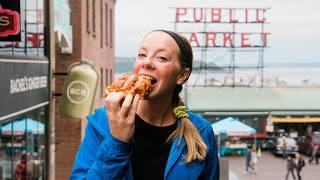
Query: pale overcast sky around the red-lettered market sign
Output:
[[115, 0, 320, 63]]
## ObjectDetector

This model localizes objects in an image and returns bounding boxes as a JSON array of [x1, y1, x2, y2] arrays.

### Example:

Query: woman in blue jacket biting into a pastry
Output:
[[70, 30, 219, 180]]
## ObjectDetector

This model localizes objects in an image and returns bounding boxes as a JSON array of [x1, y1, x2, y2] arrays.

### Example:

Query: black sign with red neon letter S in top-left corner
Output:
[[0, 0, 21, 41]]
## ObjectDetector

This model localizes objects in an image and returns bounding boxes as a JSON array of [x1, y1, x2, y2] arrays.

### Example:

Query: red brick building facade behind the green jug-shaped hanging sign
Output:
[[54, 0, 115, 179]]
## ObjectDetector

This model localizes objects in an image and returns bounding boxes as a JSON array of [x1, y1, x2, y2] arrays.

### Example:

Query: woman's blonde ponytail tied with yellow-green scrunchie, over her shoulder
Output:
[[167, 97, 207, 163]]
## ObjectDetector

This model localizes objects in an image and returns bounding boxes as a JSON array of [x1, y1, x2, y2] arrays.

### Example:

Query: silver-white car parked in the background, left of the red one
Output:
[[272, 137, 299, 155]]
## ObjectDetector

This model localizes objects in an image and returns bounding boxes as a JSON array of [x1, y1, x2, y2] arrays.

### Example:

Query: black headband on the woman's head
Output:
[[155, 29, 192, 71]]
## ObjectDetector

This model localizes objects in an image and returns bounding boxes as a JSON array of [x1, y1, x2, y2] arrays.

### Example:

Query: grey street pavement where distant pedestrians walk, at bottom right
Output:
[[226, 151, 320, 180]]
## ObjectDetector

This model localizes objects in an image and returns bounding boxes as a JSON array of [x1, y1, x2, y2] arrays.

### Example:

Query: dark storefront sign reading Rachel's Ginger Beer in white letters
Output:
[[0, 59, 49, 121]]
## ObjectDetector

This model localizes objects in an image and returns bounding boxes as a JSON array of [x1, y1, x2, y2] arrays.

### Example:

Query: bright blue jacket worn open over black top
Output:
[[70, 108, 219, 180]]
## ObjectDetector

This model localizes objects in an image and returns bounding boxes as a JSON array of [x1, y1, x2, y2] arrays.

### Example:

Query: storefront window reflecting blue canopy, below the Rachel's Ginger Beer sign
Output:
[[0, 107, 47, 179]]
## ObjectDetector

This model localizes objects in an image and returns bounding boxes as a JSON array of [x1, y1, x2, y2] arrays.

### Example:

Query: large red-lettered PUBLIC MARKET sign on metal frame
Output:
[[174, 7, 270, 48]]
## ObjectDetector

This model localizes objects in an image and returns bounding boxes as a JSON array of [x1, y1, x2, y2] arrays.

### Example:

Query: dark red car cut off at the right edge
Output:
[[298, 132, 320, 156]]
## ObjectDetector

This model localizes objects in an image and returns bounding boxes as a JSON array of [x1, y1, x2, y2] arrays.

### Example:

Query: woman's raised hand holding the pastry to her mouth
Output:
[[106, 92, 140, 142]]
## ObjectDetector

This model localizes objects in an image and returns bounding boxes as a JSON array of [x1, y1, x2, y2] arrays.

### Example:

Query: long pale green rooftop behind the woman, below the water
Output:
[[184, 87, 320, 112]]
